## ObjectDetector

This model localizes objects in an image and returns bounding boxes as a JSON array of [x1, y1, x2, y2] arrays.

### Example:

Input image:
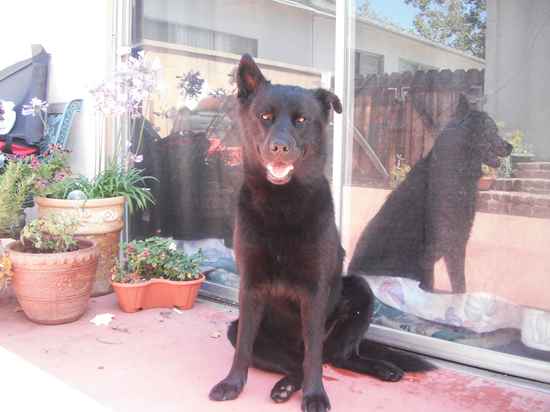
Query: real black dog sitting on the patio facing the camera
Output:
[[210, 55, 434, 412]]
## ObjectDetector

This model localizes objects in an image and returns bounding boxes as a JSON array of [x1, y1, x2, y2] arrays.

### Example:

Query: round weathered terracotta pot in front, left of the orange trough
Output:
[[6, 239, 99, 325]]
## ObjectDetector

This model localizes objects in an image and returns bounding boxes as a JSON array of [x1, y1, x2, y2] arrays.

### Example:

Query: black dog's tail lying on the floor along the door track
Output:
[[359, 339, 437, 372]]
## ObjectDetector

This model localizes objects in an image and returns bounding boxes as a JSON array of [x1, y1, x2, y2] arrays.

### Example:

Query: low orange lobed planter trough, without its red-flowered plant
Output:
[[113, 275, 204, 313]]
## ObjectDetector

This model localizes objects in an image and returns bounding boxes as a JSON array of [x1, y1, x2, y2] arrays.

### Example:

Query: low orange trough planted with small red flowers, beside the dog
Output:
[[112, 237, 204, 312]]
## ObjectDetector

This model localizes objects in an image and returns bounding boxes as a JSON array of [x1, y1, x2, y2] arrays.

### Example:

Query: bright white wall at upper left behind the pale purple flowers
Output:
[[0, 0, 112, 175]]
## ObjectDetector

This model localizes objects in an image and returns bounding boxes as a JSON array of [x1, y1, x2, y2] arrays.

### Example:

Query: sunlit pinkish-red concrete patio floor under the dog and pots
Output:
[[0, 294, 550, 412]]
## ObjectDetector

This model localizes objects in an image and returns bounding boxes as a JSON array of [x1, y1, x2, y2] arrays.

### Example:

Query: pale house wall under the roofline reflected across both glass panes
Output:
[[144, 0, 483, 72]]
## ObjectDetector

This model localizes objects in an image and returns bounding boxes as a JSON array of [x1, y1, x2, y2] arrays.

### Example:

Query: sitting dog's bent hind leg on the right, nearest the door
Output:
[[324, 275, 403, 381]]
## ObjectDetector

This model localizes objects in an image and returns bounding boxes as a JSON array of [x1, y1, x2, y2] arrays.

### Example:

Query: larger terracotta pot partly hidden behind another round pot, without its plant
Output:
[[34, 196, 125, 296]]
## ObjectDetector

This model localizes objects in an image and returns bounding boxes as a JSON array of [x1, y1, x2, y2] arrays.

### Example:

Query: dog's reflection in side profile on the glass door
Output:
[[349, 95, 512, 293]]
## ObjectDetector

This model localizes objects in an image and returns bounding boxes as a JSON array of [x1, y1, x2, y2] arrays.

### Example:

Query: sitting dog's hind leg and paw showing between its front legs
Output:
[[227, 320, 304, 403]]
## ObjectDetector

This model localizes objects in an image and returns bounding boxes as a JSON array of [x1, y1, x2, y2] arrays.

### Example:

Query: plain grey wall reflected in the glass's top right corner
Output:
[[486, 0, 550, 159]]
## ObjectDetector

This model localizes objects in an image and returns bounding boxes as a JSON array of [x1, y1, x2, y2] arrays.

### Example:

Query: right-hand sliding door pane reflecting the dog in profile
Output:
[[338, 0, 550, 382]]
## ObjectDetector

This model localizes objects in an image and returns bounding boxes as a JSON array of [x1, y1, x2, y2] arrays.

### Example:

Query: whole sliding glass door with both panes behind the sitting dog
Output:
[[130, 0, 550, 382]]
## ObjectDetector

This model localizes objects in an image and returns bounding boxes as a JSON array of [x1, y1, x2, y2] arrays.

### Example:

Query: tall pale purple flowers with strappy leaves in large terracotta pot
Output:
[[41, 48, 160, 296]]
